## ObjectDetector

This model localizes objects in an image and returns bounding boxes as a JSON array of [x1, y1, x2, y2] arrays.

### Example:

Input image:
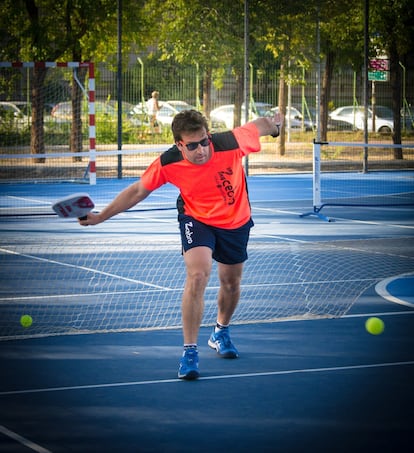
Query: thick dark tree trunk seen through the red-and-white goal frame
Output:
[[30, 67, 47, 163]]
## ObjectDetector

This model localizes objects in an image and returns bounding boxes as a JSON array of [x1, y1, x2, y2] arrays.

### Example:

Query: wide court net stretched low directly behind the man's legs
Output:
[[0, 237, 413, 340]]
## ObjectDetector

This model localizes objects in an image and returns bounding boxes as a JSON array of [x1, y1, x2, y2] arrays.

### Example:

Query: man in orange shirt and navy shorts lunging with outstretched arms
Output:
[[79, 110, 281, 380]]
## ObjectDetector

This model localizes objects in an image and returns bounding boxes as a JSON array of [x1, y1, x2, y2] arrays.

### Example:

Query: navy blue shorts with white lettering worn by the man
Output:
[[178, 214, 254, 264]]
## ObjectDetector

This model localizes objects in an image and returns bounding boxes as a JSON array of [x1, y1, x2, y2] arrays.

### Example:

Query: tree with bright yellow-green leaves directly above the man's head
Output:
[[141, 0, 244, 120]]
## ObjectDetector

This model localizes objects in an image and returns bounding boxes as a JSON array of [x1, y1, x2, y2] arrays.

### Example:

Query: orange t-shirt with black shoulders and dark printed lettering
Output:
[[141, 123, 261, 229]]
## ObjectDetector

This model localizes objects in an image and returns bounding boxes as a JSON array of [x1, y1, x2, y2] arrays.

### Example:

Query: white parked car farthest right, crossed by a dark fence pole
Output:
[[329, 105, 394, 134]]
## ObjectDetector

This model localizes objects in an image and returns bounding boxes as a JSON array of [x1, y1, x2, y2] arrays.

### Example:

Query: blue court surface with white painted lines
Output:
[[0, 172, 414, 453]]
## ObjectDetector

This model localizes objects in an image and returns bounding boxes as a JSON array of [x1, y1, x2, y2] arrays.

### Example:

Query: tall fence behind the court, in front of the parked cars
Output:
[[0, 57, 414, 179]]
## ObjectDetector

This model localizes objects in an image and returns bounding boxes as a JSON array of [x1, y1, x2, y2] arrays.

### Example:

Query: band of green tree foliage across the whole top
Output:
[[0, 0, 414, 147]]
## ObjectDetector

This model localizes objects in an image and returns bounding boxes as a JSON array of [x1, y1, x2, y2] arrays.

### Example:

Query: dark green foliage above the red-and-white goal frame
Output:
[[0, 0, 145, 61]]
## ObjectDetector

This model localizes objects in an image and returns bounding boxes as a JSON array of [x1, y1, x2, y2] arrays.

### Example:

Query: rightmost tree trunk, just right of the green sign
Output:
[[389, 42, 403, 159]]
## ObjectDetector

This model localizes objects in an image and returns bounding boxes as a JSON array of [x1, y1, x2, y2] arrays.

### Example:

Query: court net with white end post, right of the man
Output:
[[302, 142, 414, 220]]
